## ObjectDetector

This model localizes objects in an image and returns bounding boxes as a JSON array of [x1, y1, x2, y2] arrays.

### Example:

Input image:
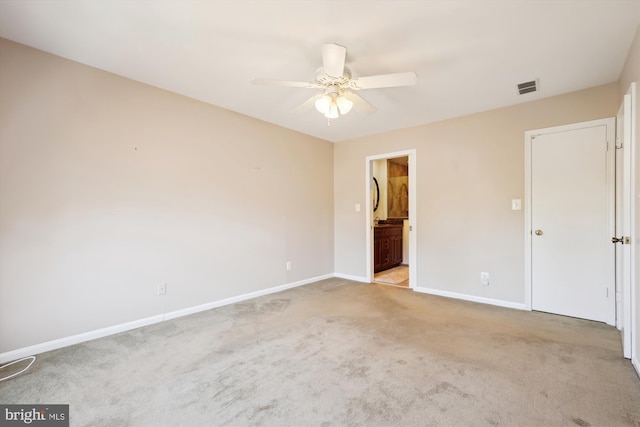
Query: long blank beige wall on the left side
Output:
[[0, 40, 334, 353]]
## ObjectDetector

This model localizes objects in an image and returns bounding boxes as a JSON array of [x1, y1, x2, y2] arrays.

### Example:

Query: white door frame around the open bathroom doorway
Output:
[[365, 148, 418, 289]]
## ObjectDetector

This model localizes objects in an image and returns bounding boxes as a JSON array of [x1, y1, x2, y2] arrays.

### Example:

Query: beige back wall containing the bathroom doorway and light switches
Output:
[[334, 84, 619, 304]]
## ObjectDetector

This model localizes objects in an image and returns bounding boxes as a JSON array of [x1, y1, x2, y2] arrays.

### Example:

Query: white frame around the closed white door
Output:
[[524, 117, 616, 326]]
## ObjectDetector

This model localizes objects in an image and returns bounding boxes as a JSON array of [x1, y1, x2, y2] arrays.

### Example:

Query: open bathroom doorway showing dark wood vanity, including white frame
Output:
[[366, 150, 417, 288]]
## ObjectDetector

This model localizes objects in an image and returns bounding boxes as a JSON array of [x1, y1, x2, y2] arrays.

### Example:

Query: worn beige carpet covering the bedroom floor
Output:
[[0, 279, 640, 427]]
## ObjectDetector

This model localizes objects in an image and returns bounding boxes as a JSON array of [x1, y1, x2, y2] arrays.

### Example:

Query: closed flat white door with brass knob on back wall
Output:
[[529, 119, 615, 324]]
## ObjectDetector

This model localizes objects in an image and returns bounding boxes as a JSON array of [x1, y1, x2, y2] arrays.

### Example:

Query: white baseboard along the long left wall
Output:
[[0, 274, 334, 363]]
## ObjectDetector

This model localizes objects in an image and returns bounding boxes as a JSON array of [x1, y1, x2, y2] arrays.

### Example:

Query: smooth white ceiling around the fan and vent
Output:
[[0, 0, 640, 142]]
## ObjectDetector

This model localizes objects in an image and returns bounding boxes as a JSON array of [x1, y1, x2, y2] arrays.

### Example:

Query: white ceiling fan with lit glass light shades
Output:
[[252, 43, 418, 119]]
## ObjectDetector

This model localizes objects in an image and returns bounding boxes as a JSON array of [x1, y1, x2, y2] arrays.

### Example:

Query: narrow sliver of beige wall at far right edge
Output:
[[620, 27, 640, 373]]
